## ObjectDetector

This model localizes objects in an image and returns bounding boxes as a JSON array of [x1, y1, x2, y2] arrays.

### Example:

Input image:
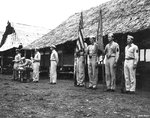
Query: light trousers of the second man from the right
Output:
[[105, 57, 116, 90]]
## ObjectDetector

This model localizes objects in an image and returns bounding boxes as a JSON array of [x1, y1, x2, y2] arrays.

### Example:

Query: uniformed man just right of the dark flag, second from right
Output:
[[105, 33, 119, 92]]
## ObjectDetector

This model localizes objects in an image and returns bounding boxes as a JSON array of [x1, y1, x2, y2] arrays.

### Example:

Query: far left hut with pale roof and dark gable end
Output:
[[0, 22, 49, 73]]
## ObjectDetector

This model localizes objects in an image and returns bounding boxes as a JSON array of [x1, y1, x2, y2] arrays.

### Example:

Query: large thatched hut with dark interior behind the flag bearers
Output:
[[25, 0, 150, 89]]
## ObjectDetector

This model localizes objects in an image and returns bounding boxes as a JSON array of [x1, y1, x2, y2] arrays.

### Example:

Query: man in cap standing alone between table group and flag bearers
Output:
[[49, 45, 59, 84]]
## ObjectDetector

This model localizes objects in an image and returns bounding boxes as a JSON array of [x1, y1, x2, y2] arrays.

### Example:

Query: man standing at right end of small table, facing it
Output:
[[31, 48, 41, 82]]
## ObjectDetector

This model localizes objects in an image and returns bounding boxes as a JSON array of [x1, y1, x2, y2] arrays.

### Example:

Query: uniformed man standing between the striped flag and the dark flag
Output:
[[86, 36, 98, 89]]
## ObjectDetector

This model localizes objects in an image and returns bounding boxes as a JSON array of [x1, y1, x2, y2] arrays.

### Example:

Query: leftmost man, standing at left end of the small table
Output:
[[13, 49, 21, 80]]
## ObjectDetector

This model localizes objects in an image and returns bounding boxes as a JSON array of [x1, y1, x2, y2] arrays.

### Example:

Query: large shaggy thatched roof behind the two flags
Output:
[[25, 0, 150, 49]]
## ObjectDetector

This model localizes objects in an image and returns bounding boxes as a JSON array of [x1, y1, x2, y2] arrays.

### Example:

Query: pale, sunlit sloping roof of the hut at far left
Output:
[[0, 22, 50, 51]]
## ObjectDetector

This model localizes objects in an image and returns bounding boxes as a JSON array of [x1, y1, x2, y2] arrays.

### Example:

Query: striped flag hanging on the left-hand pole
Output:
[[76, 12, 85, 51]]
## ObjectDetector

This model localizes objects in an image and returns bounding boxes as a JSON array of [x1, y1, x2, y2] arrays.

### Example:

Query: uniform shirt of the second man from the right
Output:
[[105, 41, 119, 62]]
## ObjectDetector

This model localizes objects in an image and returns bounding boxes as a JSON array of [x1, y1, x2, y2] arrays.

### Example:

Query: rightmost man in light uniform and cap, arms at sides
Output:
[[124, 35, 139, 93]]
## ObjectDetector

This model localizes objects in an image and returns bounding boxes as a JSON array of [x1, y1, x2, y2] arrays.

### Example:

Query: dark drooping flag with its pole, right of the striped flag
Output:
[[97, 9, 105, 91]]
